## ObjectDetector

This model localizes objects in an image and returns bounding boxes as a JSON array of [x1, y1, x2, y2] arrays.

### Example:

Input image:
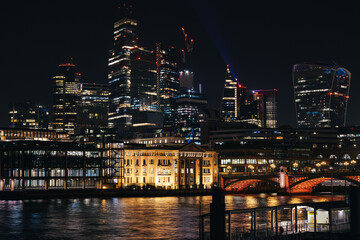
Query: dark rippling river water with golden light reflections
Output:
[[0, 194, 343, 240]]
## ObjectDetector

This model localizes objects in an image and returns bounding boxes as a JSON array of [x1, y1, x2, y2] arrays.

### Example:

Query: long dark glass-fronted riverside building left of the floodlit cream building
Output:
[[0, 140, 123, 191]]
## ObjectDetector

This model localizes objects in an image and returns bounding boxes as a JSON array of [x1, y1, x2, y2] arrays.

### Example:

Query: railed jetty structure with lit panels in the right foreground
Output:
[[199, 201, 350, 240]]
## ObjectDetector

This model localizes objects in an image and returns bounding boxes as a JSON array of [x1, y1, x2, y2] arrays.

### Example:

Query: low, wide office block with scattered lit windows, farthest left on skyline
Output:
[[9, 102, 49, 129]]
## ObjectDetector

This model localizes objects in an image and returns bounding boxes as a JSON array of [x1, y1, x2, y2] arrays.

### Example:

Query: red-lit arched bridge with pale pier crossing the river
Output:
[[220, 170, 360, 193]]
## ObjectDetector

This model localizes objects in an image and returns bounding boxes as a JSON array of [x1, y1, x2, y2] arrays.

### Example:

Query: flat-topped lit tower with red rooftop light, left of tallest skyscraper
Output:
[[52, 63, 81, 134]]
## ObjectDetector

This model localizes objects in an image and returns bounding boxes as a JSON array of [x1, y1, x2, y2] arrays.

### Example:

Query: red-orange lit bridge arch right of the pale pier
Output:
[[289, 176, 360, 193]]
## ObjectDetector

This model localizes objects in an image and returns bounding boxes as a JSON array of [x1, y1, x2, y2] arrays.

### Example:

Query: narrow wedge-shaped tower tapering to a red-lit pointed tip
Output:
[[221, 66, 240, 122]]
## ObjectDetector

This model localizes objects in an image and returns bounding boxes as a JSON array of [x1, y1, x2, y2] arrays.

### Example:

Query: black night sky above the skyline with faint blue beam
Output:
[[0, 0, 360, 126]]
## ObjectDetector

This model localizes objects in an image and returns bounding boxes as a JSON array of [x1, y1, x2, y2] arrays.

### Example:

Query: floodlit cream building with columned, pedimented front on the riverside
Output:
[[124, 143, 218, 189]]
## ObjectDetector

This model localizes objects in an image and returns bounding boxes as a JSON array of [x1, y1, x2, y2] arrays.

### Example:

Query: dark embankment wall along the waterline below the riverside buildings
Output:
[[0, 189, 212, 200]]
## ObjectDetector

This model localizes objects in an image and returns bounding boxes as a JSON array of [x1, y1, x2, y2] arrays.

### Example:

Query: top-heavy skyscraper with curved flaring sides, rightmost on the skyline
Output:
[[293, 63, 351, 128]]
